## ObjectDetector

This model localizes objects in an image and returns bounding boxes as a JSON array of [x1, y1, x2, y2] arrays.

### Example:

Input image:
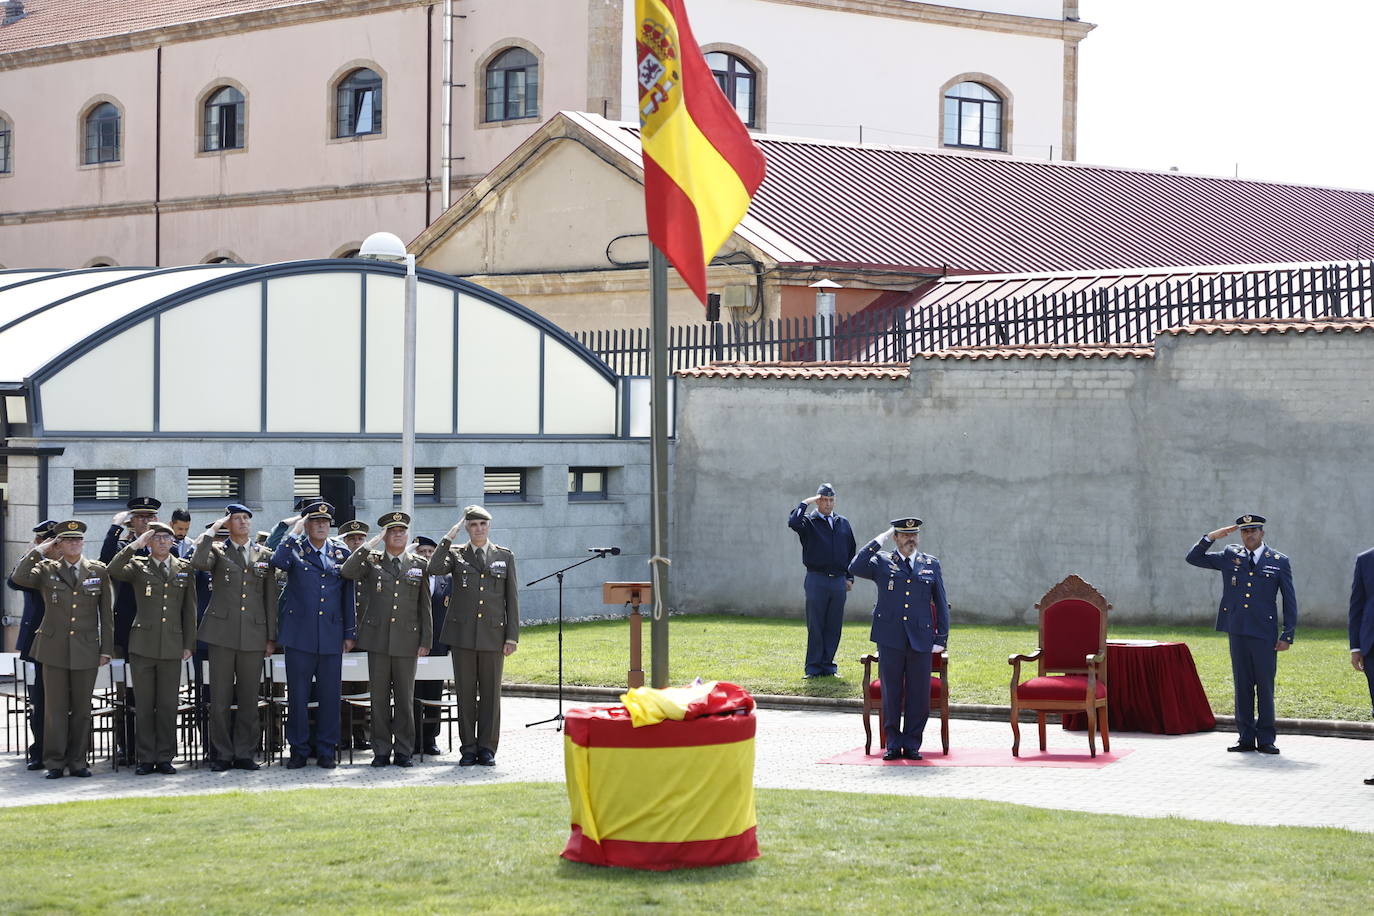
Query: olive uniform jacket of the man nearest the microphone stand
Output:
[[426, 537, 519, 652]]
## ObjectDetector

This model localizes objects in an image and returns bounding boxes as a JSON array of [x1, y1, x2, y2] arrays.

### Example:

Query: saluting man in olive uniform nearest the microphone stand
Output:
[[426, 505, 519, 766]]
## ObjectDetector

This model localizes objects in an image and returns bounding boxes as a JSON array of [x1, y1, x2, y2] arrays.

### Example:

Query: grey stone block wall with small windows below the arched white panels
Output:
[[0, 438, 649, 631]]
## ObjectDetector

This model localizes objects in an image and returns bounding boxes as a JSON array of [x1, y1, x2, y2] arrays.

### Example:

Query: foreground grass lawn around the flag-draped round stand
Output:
[[0, 784, 1374, 915]]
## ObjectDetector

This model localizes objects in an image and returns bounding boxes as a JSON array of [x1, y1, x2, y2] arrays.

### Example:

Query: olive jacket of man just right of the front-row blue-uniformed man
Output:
[[339, 547, 434, 658]]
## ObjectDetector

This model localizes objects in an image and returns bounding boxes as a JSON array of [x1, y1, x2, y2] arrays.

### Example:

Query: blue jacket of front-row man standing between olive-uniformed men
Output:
[[272, 537, 357, 655]]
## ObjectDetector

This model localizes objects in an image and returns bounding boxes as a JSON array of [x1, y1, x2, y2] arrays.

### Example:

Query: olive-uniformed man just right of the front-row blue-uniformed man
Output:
[[339, 512, 434, 766]]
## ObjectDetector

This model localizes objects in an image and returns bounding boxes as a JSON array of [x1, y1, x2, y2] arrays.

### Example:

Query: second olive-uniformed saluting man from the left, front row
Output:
[[110, 522, 195, 776]]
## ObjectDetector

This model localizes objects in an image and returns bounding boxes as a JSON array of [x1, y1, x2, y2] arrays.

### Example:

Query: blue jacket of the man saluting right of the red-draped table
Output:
[[1187, 537, 1297, 643]]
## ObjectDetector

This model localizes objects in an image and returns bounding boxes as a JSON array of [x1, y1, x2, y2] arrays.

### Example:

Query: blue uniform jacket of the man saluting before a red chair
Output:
[[849, 541, 949, 652]]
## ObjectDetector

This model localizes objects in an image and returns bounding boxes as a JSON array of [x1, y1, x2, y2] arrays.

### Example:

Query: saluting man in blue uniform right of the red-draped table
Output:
[[1187, 515, 1297, 754]]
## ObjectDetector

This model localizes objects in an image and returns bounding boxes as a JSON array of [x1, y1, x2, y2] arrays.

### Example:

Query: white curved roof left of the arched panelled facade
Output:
[[0, 265, 246, 382]]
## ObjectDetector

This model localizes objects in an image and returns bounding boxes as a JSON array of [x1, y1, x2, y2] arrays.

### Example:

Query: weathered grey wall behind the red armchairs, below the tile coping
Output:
[[673, 330, 1374, 639]]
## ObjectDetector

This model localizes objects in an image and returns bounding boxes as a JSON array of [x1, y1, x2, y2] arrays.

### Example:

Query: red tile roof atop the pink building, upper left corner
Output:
[[0, 0, 319, 55]]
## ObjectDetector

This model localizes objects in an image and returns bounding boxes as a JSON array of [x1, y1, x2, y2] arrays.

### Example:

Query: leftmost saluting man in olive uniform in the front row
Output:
[[12, 522, 114, 779]]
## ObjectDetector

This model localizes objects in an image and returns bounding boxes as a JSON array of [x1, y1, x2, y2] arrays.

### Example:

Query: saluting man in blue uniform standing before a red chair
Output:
[[849, 518, 949, 761]]
